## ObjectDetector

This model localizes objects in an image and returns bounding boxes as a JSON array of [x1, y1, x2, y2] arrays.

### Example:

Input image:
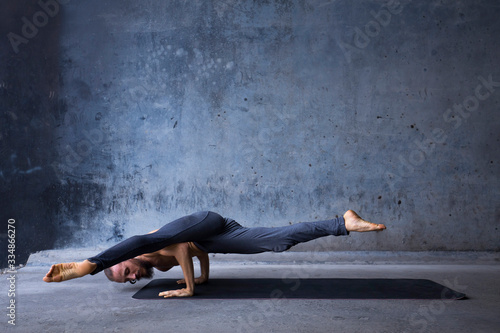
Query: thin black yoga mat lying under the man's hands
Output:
[[132, 279, 466, 299]]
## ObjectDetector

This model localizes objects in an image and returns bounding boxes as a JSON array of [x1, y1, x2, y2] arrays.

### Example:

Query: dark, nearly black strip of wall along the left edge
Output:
[[0, 0, 61, 268]]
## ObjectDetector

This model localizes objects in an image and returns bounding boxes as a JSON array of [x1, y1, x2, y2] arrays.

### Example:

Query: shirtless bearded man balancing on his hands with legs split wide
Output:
[[43, 210, 385, 297]]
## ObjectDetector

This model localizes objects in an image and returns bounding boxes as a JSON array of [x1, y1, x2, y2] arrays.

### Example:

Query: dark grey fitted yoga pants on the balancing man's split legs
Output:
[[88, 212, 349, 275]]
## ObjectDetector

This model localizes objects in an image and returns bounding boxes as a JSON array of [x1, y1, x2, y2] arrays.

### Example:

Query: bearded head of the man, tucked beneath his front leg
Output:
[[104, 258, 153, 283]]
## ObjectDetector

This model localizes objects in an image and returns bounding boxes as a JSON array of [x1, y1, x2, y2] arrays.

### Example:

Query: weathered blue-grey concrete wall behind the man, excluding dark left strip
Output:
[[2, 0, 500, 264]]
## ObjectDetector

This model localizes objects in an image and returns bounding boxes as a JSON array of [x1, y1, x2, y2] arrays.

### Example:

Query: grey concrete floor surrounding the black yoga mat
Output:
[[0, 250, 500, 333]]
